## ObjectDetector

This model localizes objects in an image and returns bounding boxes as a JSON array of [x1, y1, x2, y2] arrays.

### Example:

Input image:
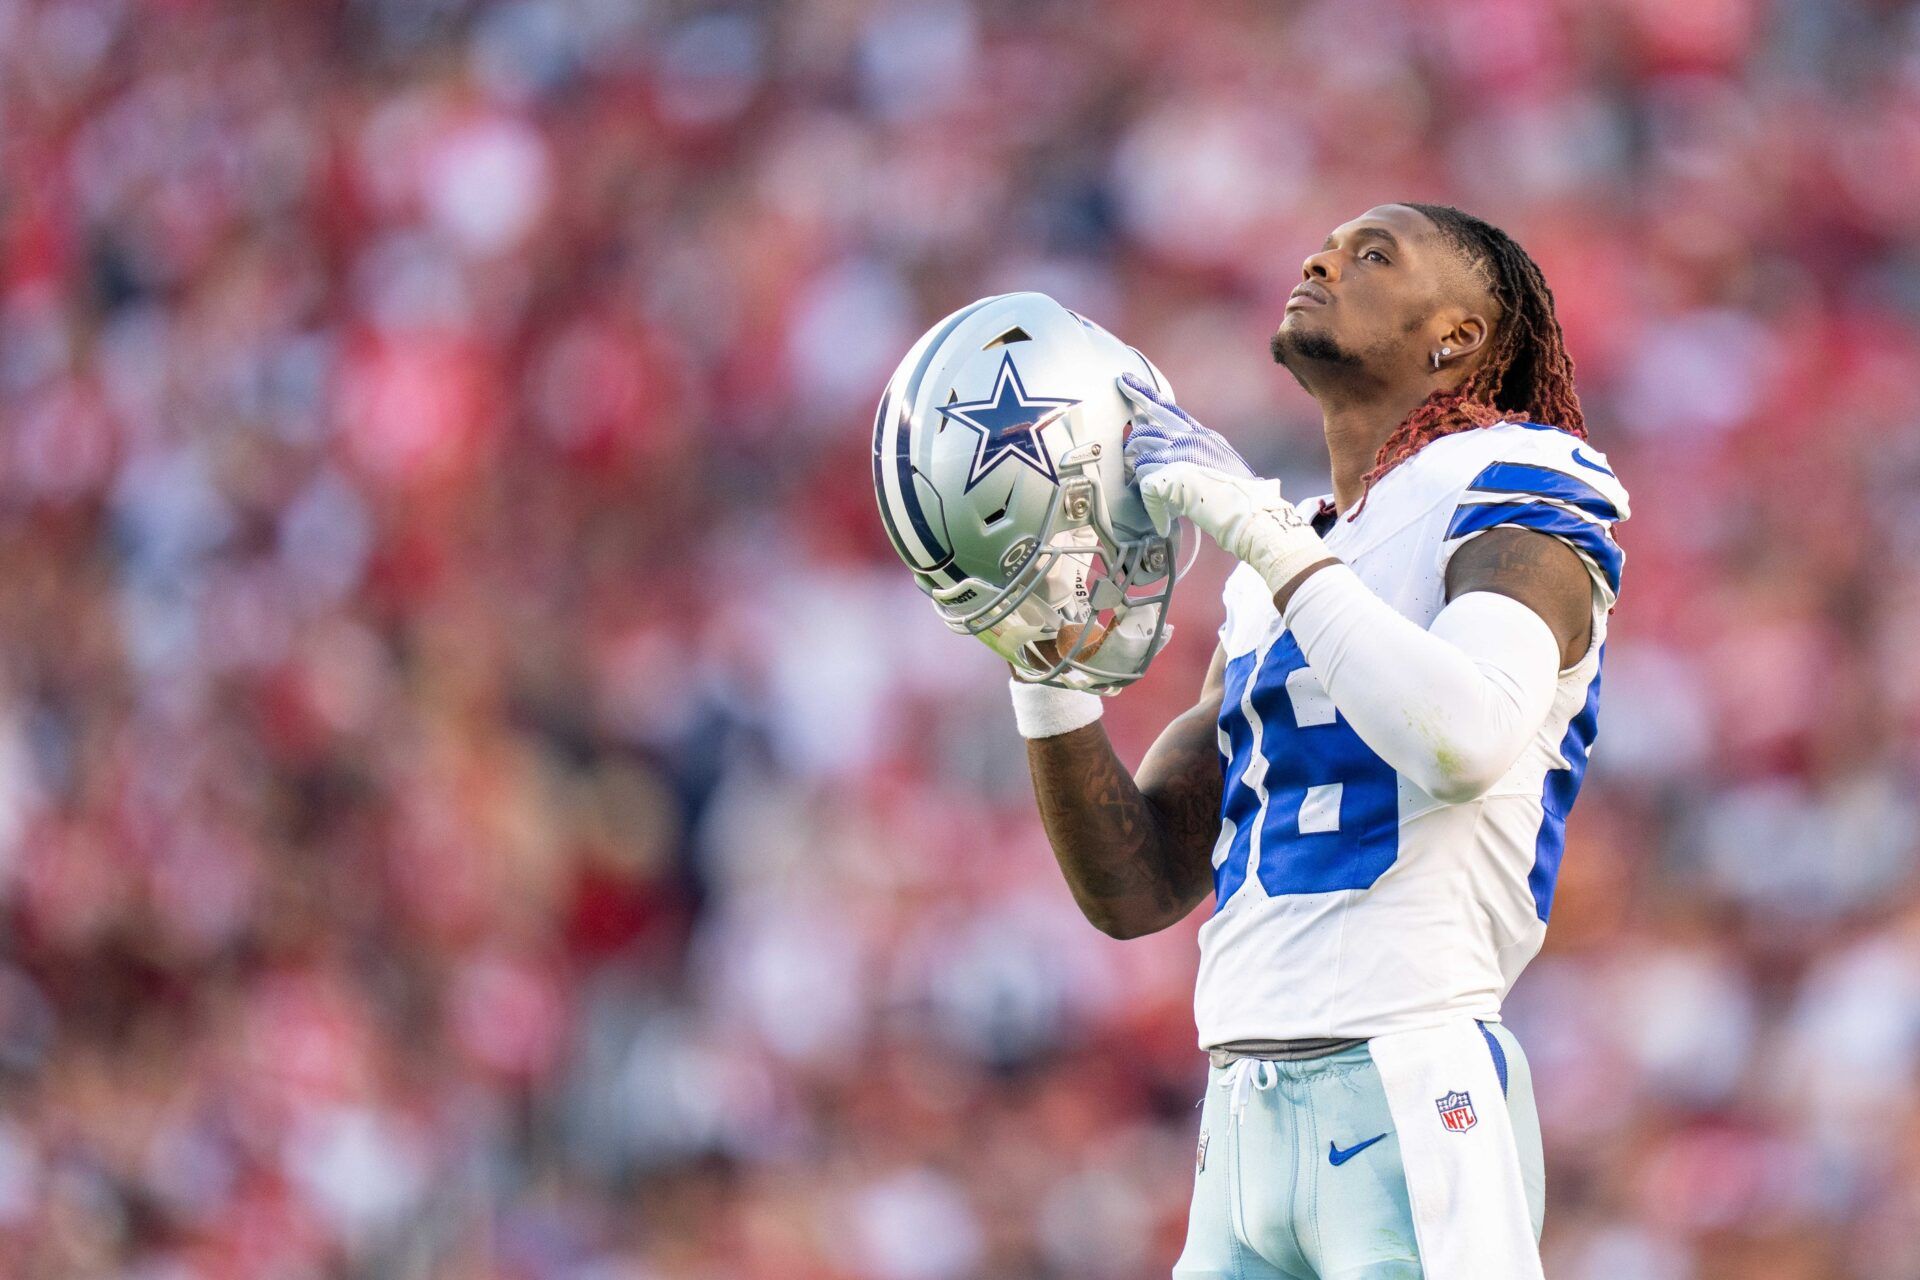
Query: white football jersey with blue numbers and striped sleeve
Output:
[[1194, 422, 1628, 1048]]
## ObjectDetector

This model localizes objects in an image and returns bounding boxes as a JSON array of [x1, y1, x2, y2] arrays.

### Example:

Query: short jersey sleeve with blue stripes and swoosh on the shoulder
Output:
[[1440, 428, 1628, 614]]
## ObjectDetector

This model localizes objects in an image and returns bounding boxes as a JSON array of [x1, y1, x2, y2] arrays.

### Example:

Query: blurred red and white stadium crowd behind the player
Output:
[[0, 0, 1920, 1280]]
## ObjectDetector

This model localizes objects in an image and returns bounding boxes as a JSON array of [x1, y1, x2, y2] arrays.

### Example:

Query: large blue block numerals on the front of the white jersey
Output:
[[1213, 631, 1400, 912]]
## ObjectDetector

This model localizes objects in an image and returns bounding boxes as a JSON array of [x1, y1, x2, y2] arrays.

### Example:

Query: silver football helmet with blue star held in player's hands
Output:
[[874, 294, 1179, 693]]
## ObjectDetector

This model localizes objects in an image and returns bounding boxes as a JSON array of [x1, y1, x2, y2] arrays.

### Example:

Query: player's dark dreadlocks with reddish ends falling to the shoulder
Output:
[[1348, 203, 1586, 520]]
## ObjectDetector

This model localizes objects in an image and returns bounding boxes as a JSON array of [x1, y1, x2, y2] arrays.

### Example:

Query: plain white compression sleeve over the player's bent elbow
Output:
[[1286, 564, 1559, 804]]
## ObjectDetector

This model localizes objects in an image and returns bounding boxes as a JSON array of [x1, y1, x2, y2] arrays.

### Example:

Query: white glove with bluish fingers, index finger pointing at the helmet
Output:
[[1119, 374, 1332, 593]]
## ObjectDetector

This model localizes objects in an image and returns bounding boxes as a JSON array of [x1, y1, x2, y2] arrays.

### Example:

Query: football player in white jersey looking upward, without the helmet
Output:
[[1014, 203, 1628, 1280]]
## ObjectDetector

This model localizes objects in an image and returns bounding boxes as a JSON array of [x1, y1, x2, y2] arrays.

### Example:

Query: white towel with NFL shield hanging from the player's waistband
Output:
[[1367, 1017, 1542, 1280]]
